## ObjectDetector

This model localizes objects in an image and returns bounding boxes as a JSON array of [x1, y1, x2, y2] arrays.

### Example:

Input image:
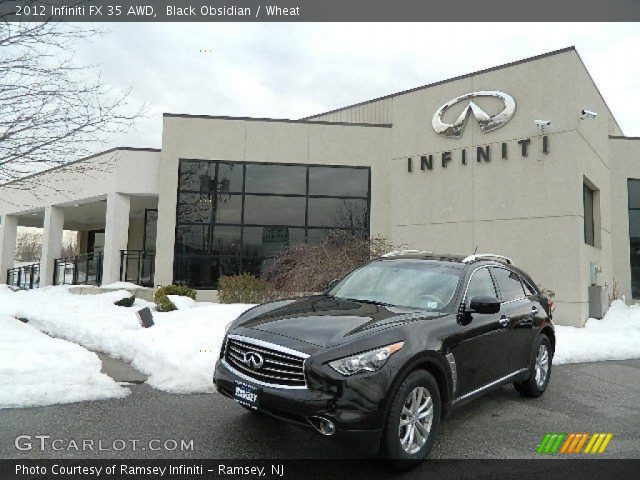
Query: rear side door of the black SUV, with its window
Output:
[[491, 267, 538, 376]]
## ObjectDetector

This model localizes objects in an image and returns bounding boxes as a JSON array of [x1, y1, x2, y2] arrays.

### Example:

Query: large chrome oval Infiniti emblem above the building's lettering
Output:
[[431, 90, 516, 138]]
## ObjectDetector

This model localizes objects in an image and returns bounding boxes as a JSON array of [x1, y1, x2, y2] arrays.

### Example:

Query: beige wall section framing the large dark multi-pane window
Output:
[[155, 116, 391, 288]]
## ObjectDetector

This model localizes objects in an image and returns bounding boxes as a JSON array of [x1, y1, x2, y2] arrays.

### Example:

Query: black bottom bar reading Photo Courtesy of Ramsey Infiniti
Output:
[[0, 457, 640, 480]]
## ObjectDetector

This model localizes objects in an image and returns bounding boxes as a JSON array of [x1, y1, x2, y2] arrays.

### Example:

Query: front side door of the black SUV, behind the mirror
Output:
[[450, 267, 508, 397]]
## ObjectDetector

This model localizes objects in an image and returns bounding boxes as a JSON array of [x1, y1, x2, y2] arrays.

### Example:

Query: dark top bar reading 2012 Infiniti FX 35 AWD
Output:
[[0, 0, 640, 21]]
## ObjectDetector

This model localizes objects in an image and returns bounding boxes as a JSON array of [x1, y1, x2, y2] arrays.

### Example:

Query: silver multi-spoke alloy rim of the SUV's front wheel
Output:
[[398, 387, 433, 455]]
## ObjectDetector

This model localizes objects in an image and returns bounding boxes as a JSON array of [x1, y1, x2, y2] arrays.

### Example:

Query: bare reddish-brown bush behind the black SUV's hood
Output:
[[263, 230, 394, 295]]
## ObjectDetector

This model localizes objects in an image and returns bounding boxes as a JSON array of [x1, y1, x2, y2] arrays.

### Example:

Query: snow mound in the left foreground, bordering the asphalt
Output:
[[0, 316, 129, 408]]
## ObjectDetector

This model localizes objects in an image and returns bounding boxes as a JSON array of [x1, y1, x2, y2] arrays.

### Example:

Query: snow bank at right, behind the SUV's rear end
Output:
[[553, 300, 640, 364]]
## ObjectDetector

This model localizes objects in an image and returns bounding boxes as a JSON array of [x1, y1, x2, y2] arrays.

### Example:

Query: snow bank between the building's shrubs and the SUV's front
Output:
[[0, 286, 252, 393]]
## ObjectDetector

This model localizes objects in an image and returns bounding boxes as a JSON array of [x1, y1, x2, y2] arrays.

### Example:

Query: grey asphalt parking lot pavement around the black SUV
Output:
[[0, 360, 640, 459]]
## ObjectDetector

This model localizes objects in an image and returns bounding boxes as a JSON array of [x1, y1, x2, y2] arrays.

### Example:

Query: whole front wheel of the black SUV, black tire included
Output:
[[381, 370, 441, 470]]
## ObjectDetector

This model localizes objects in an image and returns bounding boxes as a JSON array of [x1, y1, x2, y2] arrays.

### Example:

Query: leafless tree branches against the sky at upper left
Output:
[[0, 0, 146, 184]]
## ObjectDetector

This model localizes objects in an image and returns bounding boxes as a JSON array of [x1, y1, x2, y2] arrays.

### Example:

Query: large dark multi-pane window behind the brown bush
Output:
[[174, 160, 370, 289]]
